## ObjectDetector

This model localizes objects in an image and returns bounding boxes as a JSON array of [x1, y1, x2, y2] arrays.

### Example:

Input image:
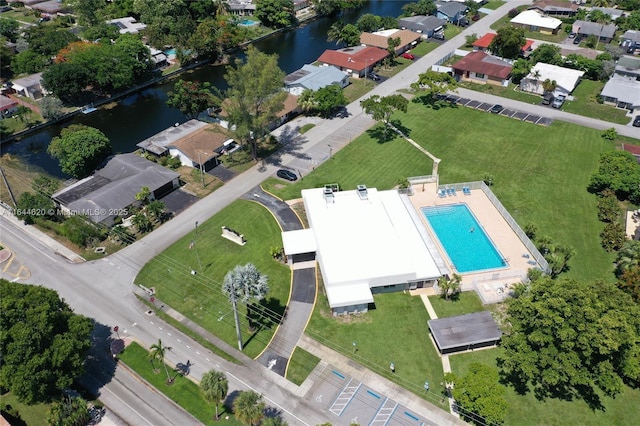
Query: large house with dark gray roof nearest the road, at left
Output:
[[51, 153, 180, 226]]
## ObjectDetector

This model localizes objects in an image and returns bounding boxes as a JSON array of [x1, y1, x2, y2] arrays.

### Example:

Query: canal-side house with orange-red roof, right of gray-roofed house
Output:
[[318, 46, 389, 78]]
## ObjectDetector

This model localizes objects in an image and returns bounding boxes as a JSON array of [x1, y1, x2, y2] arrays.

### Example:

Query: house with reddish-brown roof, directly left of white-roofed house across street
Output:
[[451, 52, 512, 86]]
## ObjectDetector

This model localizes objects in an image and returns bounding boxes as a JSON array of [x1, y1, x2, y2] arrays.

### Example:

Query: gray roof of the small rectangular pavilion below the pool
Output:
[[428, 311, 502, 351]]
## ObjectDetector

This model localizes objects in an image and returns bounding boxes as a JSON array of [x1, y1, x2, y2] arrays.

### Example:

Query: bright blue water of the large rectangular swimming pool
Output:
[[422, 204, 507, 272]]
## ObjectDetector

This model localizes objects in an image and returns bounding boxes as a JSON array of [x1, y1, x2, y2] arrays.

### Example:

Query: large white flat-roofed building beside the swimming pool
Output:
[[283, 185, 441, 315]]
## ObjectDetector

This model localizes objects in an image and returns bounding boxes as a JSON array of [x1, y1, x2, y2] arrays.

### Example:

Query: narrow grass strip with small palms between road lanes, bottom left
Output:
[[119, 343, 242, 425]]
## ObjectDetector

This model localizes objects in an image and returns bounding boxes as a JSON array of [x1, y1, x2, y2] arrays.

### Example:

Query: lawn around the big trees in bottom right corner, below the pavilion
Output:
[[449, 348, 640, 426]]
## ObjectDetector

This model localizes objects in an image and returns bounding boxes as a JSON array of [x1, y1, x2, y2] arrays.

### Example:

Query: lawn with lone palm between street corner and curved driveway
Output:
[[135, 200, 291, 357]]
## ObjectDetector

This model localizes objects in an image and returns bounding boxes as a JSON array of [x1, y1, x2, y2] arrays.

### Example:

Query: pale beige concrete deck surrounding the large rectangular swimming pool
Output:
[[409, 183, 535, 303]]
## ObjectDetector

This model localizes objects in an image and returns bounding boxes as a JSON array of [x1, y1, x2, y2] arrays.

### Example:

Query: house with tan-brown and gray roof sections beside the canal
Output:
[[137, 119, 233, 170]]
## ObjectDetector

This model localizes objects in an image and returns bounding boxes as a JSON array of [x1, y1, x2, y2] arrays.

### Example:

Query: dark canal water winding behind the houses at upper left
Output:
[[2, 0, 410, 177]]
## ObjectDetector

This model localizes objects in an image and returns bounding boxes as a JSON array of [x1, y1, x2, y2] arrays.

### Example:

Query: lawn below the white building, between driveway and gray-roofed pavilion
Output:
[[306, 292, 443, 404]]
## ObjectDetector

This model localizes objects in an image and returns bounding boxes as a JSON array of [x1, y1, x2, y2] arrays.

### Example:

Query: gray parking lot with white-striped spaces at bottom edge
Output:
[[311, 367, 432, 426]]
